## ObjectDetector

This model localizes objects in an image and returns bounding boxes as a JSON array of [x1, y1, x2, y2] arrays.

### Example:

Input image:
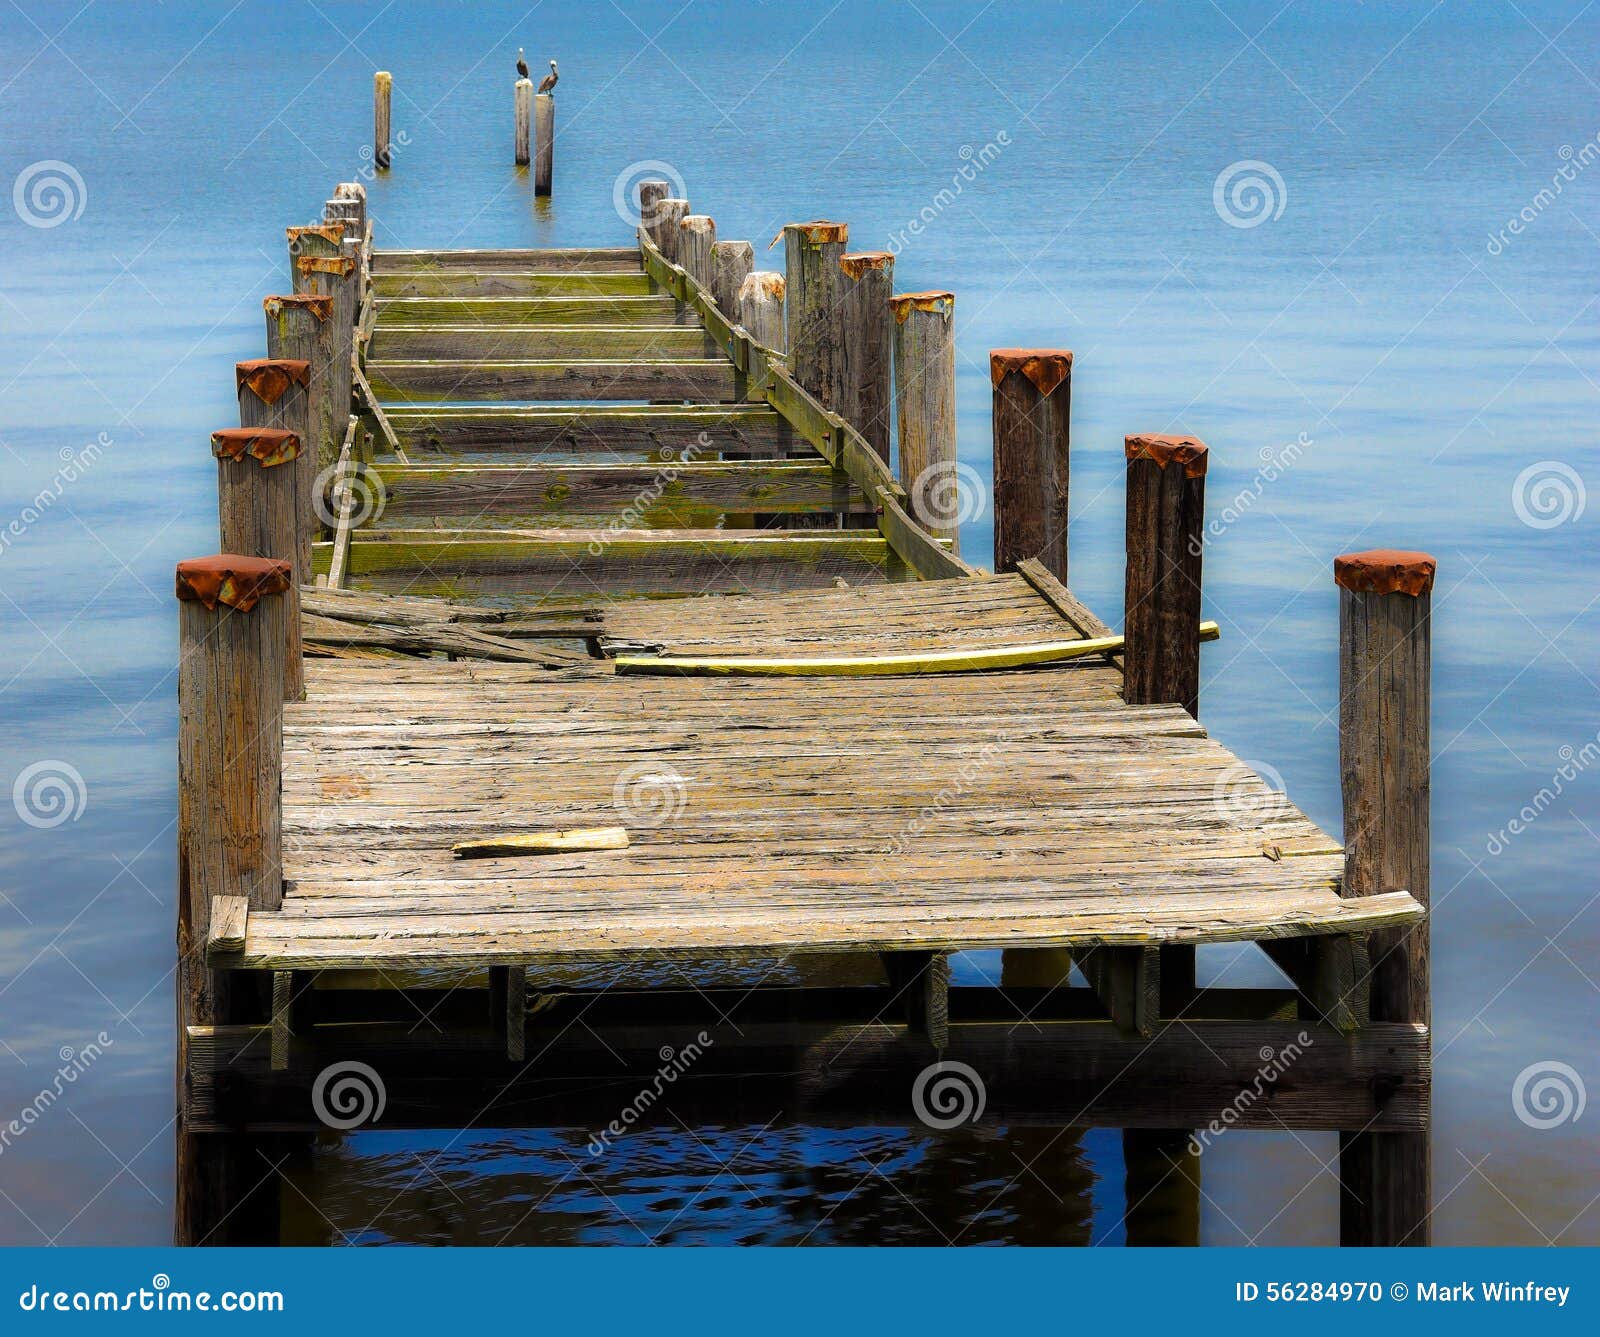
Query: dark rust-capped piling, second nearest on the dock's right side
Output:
[[1123, 435, 1206, 716]]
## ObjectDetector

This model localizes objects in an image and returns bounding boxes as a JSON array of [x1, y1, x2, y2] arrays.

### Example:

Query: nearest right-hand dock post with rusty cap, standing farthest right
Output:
[[1333, 549, 1437, 1246]]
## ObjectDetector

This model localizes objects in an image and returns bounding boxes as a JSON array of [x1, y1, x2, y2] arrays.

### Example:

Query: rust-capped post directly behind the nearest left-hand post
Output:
[[211, 427, 310, 700]]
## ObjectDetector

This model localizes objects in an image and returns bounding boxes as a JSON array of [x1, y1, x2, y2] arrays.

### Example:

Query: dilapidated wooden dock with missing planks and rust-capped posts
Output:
[[176, 172, 1432, 1243]]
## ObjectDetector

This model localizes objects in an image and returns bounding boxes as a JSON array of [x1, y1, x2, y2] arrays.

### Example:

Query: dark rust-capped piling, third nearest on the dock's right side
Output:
[[989, 349, 1072, 584]]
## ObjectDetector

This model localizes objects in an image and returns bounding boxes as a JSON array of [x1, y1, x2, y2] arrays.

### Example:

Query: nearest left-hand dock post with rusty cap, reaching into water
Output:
[[173, 555, 293, 1244]]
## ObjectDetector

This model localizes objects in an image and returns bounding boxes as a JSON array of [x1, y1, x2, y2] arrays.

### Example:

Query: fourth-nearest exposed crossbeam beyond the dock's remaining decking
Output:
[[366, 358, 739, 403]]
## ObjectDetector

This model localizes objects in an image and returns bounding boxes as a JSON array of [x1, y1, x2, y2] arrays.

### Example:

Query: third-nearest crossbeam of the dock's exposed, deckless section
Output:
[[389, 405, 806, 459]]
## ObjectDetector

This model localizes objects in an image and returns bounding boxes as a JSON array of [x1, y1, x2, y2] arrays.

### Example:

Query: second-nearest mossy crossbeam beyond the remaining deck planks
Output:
[[374, 461, 870, 529]]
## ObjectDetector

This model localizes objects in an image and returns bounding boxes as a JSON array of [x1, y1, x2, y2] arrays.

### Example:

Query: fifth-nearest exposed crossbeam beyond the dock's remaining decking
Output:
[[366, 321, 722, 361]]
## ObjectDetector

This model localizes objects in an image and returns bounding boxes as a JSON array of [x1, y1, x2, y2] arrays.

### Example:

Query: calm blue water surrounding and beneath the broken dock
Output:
[[0, 0, 1600, 1244]]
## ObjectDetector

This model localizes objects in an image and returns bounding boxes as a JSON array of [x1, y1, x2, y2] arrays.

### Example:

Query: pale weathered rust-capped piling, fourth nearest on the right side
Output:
[[890, 293, 958, 537]]
